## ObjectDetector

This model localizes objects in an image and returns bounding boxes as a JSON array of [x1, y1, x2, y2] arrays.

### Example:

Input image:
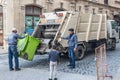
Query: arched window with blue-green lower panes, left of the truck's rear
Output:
[[25, 5, 42, 34]]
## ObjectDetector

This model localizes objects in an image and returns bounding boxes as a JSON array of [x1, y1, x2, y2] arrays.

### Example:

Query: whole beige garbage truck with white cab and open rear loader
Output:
[[32, 11, 119, 59]]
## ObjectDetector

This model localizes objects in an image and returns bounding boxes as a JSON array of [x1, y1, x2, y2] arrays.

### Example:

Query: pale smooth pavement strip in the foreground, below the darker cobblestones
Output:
[[0, 66, 96, 80]]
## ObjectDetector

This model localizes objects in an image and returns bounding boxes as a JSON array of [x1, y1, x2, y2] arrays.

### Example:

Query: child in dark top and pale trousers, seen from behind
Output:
[[49, 45, 60, 80]]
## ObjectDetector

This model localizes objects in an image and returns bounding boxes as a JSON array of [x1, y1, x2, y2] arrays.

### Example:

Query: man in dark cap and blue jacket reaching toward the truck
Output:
[[62, 28, 77, 69]]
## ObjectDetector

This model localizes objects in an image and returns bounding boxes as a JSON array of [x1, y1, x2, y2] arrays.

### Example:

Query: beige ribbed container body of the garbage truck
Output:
[[56, 12, 107, 47]]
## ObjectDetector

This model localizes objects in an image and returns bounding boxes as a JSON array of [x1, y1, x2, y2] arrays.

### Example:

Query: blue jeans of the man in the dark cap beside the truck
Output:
[[68, 47, 75, 67]]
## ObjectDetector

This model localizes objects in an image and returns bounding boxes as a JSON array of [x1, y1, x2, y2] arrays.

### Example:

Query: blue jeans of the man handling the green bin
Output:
[[8, 45, 19, 69]]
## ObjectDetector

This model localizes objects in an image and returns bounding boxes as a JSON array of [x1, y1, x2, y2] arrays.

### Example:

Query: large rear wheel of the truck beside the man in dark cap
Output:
[[75, 45, 85, 60]]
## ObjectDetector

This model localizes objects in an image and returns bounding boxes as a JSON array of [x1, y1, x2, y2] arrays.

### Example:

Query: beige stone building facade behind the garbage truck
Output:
[[0, 0, 120, 46]]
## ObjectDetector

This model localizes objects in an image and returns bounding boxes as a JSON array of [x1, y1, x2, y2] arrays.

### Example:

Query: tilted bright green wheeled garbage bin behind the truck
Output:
[[17, 36, 41, 61]]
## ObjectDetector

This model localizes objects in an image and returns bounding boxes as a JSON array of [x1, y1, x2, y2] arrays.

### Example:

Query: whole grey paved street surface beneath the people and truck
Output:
[[0, 43, 120, 80]]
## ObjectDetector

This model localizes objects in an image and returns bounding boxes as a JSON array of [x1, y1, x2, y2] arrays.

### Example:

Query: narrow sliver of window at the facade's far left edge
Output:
[[0, 6, 3, 46]]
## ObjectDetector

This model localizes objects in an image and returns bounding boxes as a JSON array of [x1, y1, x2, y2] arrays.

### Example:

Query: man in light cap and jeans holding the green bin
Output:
[[8, 28, 24, 71]]
